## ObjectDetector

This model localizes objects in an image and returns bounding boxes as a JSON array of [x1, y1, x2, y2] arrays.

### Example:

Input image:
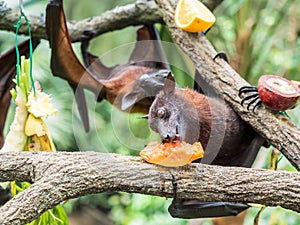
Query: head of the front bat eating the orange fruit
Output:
[[148, 72, 199, 144]]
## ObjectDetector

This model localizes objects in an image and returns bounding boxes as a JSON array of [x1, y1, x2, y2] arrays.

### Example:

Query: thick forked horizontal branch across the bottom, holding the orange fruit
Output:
[[0, 152, 300, 225]]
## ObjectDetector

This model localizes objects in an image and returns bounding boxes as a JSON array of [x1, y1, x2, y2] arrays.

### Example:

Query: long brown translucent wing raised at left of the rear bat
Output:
[[46, 0, 103, 131]]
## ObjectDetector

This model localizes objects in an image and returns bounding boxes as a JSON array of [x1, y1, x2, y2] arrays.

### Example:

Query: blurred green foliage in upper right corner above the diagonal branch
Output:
[[209, 0, 300, 84]]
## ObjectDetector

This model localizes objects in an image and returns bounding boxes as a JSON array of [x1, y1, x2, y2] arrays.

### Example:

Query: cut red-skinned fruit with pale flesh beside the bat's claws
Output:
[[257, 75, 300, 111]]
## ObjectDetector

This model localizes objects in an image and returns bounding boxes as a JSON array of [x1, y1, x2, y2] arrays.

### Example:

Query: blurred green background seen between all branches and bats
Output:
[[0, 0, 300, 225]]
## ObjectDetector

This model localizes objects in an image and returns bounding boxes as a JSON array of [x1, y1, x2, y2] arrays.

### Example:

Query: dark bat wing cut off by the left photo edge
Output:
[[0, 38, 40, 148]]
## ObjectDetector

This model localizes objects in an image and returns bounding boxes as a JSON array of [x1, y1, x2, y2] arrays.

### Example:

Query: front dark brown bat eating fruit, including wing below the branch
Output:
[[148, 73, 264, 218]]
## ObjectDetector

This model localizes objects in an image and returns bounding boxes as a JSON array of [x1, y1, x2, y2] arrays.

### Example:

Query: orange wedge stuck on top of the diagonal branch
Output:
[[175, 0, 216, 33]]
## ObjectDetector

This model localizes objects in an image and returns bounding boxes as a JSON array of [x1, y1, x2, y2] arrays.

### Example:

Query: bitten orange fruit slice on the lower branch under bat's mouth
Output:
[[140, 142, 204, 167]]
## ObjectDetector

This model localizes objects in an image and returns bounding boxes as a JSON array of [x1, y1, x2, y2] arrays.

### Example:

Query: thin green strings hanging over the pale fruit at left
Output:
[[14, 0, 35, 95]]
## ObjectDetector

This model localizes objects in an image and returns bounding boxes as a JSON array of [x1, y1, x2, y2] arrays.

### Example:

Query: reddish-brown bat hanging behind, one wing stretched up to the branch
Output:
[[46, 0, 169, 131]]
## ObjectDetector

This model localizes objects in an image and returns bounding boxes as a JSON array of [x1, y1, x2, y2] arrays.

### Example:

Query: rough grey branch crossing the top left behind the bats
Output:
[[0, 0, 222, 42]]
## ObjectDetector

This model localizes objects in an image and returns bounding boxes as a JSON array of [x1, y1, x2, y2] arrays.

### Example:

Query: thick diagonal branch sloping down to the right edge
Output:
[[156, 0, 300, 170]]
